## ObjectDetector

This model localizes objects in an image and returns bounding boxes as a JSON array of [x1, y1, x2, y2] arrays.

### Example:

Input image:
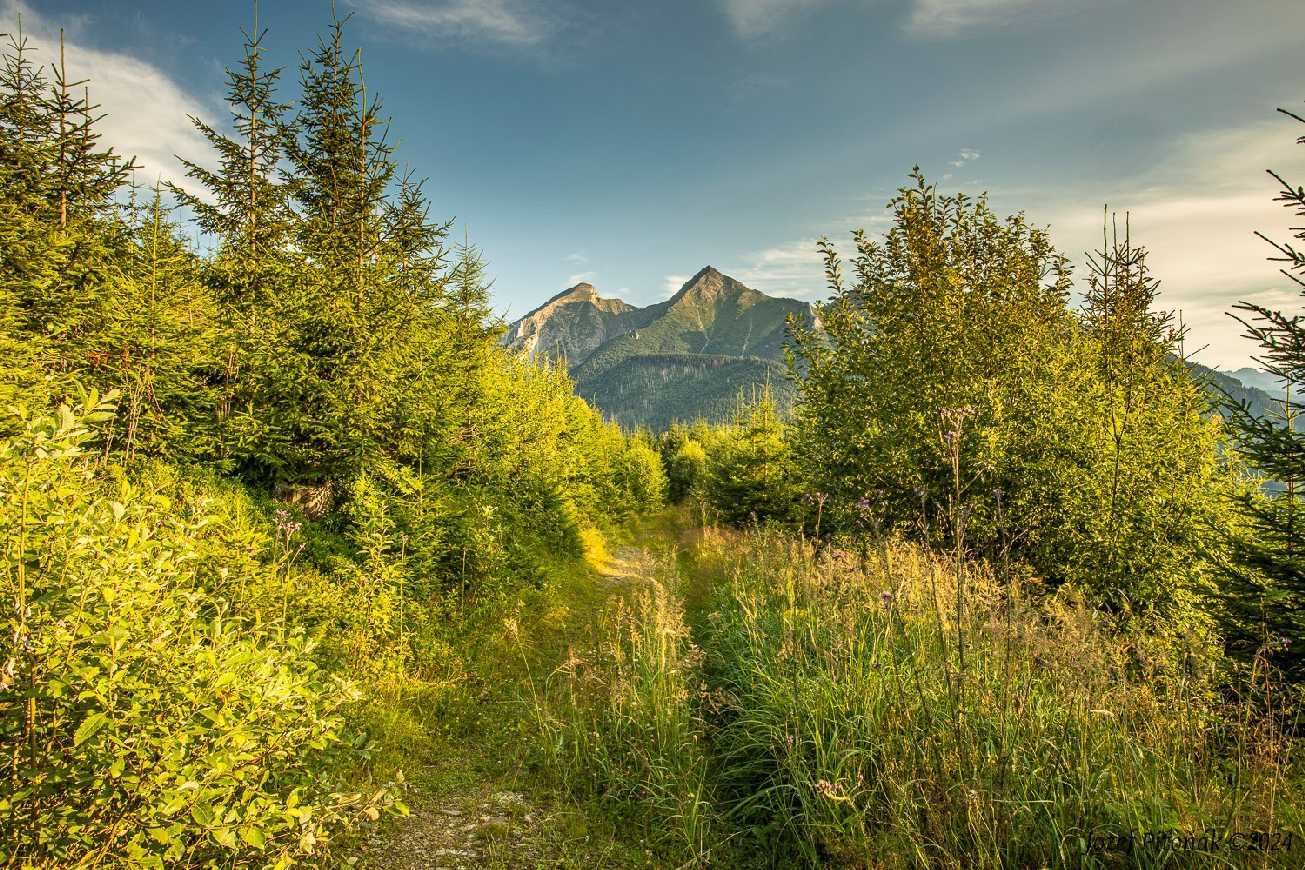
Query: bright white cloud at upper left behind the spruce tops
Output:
[[0, 0, 209, 191]]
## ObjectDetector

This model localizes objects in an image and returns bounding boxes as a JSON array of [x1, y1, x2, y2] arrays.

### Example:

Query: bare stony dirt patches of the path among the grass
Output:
[[359, 545, 655, 870]]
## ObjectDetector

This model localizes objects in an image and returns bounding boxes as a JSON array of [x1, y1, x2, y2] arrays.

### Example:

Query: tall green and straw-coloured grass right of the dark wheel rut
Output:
[[706, 531, 1300, 866]]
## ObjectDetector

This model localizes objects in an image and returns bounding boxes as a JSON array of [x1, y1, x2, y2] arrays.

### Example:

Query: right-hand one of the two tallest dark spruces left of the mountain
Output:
[[282, 10, 407, 483]]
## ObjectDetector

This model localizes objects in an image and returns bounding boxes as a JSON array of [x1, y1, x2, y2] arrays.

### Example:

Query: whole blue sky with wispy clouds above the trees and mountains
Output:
[[0, 0, 1305, 368]]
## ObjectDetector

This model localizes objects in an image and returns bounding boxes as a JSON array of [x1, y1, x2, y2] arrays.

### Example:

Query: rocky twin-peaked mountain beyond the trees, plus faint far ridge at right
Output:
[[502, 266, 1289, 430]]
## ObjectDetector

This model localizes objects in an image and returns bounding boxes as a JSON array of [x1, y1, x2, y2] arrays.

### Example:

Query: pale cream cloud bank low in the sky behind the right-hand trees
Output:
[[727, 121, 1305, 369]]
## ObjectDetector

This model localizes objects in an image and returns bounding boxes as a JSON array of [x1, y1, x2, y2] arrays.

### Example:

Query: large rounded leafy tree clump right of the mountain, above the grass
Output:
[[795, 169, 1235, 625]]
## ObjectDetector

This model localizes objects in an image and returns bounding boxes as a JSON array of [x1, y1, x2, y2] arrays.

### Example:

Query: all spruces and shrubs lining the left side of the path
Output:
[[0, 21, 664, 867]]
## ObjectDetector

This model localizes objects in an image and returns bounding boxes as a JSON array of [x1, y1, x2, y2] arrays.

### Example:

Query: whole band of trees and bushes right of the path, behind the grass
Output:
[[658, 166, 1305, 662]]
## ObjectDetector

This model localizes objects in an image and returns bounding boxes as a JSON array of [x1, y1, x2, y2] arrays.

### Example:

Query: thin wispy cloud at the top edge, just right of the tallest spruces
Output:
[[356, 0, 557, 46]]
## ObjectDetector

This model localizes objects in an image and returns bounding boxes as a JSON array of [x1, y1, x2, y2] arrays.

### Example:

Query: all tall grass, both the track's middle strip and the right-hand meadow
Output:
[[532, 521, 1305, 867]]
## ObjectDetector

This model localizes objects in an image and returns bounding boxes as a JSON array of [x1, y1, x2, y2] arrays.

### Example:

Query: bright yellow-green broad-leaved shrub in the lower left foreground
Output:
[[0, 394, 386, 867]]
